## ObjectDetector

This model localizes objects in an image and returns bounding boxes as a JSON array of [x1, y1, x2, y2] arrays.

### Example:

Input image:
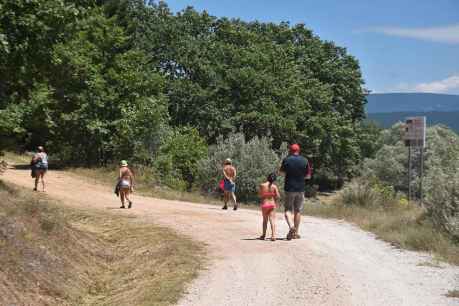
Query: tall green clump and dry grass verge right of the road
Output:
[[326, 178, 459, 264]]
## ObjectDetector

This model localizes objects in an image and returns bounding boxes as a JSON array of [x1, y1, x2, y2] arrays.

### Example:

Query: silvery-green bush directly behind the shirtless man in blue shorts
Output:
[[199, 134, 286, 201]]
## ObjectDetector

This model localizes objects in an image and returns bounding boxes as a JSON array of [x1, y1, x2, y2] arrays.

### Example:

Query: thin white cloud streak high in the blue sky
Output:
[[365, 24, 459, 44]]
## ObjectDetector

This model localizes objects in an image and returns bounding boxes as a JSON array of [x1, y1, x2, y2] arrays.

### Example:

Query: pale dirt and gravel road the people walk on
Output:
[[2, 169, 459, 306]]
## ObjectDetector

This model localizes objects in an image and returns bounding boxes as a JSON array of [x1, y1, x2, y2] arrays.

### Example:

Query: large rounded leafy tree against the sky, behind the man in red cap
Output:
[[136, 2, 365, 177]]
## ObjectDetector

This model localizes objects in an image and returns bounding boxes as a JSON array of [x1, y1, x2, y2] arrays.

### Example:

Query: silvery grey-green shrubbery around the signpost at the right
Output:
[[361, 125, 459, 239]]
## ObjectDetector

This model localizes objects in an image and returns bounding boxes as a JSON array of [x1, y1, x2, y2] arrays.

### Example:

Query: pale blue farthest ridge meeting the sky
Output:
[[366, 93, 459, 113]]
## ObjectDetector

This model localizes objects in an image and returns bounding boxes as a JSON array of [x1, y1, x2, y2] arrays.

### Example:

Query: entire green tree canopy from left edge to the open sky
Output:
[[0, 0, 365, 177]]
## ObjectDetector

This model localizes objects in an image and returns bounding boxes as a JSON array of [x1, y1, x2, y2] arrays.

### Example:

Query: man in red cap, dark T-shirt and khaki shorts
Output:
[[279, 144, 308, 240]]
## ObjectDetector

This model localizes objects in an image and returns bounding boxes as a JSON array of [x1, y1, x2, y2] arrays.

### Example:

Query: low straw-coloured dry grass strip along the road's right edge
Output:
[[305, 199, 459, 265]]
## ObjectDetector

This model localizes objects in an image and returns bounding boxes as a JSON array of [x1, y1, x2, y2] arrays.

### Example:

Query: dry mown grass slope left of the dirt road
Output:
[[0, 181, 203, 305]]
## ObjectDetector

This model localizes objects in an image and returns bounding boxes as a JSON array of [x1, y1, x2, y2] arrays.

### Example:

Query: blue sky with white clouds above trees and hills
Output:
[[166, 0, 459, 94]]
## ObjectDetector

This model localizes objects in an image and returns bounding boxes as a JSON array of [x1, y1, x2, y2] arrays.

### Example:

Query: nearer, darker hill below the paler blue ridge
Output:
[[368, 111, 459, 133]]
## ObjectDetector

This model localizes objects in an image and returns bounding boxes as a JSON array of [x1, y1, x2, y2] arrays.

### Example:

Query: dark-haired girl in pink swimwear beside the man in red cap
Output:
[[258, 173, 280, 241]]
